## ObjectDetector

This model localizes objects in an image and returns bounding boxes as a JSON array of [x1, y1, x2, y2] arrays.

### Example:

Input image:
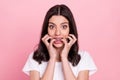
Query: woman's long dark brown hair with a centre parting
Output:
[[33, 4, 81, 66]]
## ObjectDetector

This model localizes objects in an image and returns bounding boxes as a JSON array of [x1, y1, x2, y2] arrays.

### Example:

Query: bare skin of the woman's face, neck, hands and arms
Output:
[[30, 15, 89, 80]]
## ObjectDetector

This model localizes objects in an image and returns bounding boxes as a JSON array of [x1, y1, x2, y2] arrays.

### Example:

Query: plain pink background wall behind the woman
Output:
[[0, 0, 120, 80]]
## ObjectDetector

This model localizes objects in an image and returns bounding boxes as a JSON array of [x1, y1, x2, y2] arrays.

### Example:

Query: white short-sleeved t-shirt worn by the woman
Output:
[[23, 51, 97, 80]]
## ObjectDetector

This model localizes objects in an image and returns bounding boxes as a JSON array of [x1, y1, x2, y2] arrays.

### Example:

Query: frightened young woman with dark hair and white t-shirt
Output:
[[23, 5, 97, 80]]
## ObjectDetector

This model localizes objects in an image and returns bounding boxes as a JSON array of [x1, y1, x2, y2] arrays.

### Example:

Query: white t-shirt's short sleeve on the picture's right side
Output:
[[78, 51, 97, 75]]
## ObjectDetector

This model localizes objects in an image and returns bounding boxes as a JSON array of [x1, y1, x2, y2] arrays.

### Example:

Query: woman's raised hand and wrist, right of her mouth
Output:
[[60, 34, 77, 59]]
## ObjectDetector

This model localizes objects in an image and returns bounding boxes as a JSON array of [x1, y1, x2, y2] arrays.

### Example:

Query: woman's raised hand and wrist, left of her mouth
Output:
[[42, 34, 57, 60]]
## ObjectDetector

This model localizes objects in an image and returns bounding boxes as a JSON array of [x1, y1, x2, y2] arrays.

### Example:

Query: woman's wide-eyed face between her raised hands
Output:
[[48, 15, 69, 48]]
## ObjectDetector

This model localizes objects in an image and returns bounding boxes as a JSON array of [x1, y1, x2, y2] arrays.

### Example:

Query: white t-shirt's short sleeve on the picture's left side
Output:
[[23, 53, 39, 75]]
